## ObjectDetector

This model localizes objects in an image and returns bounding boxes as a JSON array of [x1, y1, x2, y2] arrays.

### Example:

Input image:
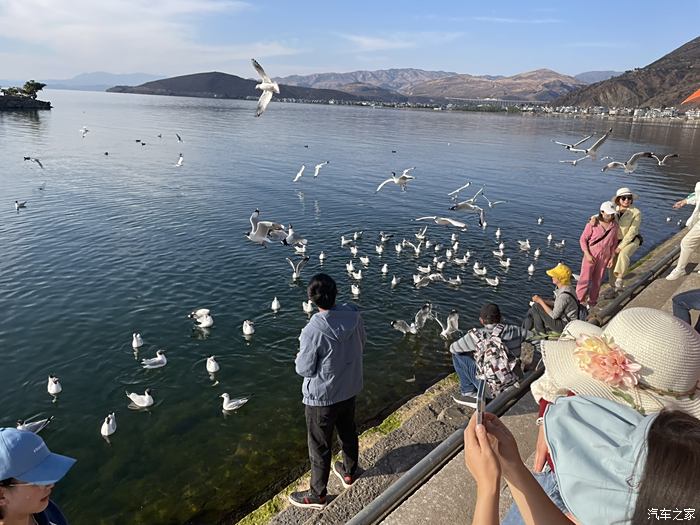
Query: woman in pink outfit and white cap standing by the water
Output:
[[576, 201, 618, 306]]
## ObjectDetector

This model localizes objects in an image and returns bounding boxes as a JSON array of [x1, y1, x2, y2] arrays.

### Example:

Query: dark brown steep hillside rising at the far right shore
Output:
[[555, 37, 700, 107]]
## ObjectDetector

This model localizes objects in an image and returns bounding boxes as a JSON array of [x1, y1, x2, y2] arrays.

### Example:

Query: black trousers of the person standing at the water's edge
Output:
[[304, 397, 359, 497]]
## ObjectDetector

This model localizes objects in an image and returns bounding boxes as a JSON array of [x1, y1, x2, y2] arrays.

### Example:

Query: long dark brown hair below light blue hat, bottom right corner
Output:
[[632, 410, 700, 525]]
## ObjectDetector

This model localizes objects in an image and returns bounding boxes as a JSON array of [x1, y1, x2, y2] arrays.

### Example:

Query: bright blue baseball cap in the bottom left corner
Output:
[[0, 428, 75, 485]]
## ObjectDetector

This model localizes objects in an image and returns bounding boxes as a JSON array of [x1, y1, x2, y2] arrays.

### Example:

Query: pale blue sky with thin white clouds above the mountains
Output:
[[0, 0, 700, 78]]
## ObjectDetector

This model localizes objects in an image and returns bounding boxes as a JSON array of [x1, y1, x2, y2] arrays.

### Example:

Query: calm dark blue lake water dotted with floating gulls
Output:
[[0, 91, 700, 525]]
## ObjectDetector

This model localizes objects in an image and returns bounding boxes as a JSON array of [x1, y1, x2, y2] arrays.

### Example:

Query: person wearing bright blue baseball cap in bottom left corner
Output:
[[0, 428, 75, 525]]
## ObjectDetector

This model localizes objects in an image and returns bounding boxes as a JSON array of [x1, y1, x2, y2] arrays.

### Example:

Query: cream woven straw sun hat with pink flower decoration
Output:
[[542, 308, 700, 418]]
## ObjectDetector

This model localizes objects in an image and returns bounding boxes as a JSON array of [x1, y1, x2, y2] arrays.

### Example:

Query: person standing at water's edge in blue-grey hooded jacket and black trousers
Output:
[[289, 273, 366, 509]]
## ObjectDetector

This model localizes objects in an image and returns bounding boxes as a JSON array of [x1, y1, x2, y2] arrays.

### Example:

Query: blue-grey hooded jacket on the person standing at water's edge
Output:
[[294, 304, 366, 406]]
